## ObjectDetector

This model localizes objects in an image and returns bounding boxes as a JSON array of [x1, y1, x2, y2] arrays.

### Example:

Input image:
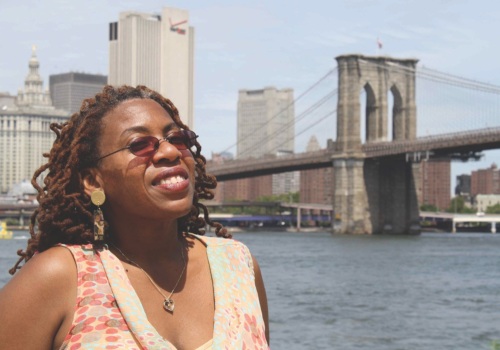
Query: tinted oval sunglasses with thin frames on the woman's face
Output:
[[97, 130, 198, 161]]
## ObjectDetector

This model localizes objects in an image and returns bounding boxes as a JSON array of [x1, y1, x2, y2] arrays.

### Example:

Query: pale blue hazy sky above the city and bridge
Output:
[[0, 0, 500, 189]]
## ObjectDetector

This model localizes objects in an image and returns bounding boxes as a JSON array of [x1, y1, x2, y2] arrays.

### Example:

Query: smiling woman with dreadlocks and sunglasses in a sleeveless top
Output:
[[0, 86, 269, 349]]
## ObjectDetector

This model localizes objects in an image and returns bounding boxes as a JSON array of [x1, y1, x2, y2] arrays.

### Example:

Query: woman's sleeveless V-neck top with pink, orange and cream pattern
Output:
[[60, 235, 269, 350]]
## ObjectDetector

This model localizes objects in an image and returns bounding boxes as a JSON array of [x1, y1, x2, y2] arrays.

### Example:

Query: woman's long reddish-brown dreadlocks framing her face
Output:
[[9, 85, 231, 274]]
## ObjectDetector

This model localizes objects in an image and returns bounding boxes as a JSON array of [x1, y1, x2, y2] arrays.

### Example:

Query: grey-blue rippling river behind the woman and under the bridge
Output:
[[0, 232, 500, 350]]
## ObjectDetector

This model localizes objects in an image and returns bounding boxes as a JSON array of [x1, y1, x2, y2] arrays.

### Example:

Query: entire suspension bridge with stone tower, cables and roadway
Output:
[[205, 55, 500, 234]]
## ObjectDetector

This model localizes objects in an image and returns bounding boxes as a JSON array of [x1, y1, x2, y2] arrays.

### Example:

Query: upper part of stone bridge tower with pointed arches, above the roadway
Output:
[[336, 55, 418, 153]]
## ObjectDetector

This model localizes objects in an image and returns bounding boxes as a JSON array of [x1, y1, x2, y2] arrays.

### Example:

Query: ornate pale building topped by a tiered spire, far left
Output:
[[0, 47, 69, 193]]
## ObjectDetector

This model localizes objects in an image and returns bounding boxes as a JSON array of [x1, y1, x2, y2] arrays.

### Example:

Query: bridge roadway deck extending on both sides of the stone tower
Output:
[[207, 128, 500, 181]]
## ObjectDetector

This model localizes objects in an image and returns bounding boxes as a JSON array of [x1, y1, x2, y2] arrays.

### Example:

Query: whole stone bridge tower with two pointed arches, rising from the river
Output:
[[333, 55, 420, 234]]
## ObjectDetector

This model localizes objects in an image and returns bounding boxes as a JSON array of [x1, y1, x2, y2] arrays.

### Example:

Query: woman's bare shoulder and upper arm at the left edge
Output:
[[0, 247, 77, 349]]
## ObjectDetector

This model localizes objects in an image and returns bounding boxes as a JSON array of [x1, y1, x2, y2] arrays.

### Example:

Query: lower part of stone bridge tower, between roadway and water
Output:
[[333, 156, 420, 234]]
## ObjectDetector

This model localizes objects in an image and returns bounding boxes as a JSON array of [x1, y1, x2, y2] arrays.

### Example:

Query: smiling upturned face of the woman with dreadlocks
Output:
[[94, 95, 195, 219]]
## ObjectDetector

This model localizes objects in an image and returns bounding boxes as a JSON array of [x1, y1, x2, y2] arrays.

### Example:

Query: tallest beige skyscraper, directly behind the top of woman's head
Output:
[[108, 7, 194, 128]]
